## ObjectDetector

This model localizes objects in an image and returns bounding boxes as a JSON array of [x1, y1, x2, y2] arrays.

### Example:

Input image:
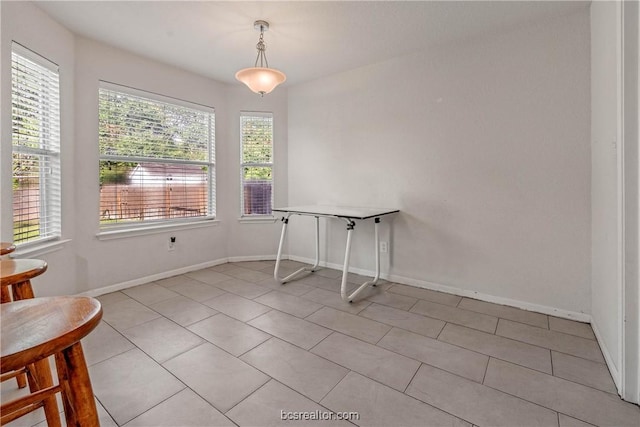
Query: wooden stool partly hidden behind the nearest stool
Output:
[[0, 258, 48, 392]]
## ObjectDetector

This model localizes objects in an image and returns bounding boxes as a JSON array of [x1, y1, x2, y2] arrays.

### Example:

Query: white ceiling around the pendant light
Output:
[[36, 0, 588, 85]]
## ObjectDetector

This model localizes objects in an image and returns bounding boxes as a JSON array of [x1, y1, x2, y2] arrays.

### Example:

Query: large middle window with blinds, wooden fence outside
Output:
[[99, 82, 215, 229]]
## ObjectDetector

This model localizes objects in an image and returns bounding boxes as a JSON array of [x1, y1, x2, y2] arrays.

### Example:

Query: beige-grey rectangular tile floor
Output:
[[2, 261, 640, 427]]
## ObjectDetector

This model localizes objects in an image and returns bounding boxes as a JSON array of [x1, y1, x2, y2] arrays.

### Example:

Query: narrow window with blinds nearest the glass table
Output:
[[240, 112, 273, 216]]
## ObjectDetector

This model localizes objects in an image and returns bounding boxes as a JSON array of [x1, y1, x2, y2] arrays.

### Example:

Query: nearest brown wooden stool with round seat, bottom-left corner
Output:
[[0, 297, 102, 427]]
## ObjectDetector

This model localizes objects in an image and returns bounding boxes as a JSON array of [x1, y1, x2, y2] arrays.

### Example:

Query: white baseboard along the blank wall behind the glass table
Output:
[[289, 256, 591, 323]]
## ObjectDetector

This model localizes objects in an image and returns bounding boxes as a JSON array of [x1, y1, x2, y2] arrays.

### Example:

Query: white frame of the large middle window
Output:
[[98, 80, 217, 232]]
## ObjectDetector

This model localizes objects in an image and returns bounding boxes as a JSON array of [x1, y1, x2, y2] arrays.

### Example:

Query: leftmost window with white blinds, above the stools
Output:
[[11, 43, 61, 244]]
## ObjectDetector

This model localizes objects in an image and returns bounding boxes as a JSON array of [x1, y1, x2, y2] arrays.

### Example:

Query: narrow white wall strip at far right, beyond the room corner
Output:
[[591, 2, 621, 384]]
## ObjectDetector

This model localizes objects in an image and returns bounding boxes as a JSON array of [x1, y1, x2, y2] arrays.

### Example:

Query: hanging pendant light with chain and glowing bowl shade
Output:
[[236, 21, 287, 96]]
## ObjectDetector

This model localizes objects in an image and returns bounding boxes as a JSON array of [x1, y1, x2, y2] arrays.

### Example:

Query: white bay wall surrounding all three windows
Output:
[[1, 2, 287, 296]]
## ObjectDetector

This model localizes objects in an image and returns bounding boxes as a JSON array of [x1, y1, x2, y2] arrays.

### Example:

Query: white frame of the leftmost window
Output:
[[11, 41, 62, 250]]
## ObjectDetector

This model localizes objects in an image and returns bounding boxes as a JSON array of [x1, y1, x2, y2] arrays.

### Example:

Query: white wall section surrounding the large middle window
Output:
[[75, 37, 230, 291]]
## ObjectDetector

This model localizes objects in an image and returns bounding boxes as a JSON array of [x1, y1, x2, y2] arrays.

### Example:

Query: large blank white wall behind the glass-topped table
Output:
[[289, 8, 591, 313]]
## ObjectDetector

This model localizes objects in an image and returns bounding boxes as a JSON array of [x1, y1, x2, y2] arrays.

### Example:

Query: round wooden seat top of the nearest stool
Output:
[[0, 297, 102, 373]]
